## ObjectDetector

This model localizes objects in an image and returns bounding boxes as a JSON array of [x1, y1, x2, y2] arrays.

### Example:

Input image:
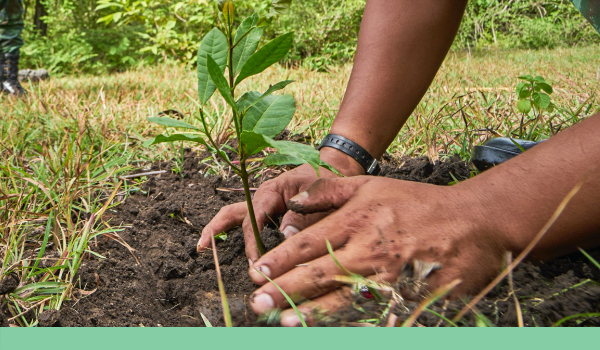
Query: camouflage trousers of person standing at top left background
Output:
[[0, 0, 23, 53]]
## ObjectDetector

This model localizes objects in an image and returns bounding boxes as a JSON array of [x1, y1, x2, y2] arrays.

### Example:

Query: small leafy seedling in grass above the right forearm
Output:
[[515, 74, 555, 139]]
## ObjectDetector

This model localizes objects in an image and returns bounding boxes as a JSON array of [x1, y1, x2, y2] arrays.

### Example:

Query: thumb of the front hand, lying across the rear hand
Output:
[[287, 176, 372, 214]]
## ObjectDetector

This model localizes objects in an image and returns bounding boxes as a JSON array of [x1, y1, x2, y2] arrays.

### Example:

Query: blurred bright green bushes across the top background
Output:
[[22, 0, 600, 74]]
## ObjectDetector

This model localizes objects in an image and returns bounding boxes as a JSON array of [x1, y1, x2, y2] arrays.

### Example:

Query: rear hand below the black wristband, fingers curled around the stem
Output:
[[197, 148, 364, 262]]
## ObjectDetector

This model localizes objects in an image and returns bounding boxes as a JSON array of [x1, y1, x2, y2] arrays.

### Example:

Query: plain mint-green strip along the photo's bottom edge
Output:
[[0, 328, 600, 350]]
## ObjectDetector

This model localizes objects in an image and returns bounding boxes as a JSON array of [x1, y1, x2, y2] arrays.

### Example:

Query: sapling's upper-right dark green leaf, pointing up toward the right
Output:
[[235, 32, 294, 85]]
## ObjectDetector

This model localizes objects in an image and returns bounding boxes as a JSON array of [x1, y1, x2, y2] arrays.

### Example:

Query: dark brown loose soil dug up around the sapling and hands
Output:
[[25, 151, 600, 327]]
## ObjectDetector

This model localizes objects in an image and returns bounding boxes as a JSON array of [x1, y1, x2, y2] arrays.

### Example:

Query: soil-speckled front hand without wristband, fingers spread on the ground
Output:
[[249, 176, 514, 326]]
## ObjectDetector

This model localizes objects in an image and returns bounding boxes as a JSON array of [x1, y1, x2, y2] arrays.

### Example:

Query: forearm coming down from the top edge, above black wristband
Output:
[[322, 0, 466, 174]]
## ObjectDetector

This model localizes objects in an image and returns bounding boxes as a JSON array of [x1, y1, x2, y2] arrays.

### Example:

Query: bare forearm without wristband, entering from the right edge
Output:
[[456, 114, 600, 260]]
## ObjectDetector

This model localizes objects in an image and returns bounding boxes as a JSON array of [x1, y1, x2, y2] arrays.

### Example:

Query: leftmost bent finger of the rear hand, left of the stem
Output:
[[196, 202, 248, 252]]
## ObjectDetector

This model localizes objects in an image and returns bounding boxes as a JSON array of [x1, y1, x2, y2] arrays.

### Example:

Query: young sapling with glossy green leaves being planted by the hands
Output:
[[148, 1, 333, 254]]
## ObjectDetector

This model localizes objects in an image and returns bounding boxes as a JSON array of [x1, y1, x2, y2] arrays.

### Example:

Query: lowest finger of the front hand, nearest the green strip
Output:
[[281, 274, 396, 327]]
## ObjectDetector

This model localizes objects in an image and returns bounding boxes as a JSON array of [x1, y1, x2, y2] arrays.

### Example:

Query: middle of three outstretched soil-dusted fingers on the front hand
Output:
[[250, 249, 386, 313]]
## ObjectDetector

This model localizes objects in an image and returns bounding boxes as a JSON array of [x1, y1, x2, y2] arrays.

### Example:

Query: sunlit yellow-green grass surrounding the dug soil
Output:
[[0, 47, 600, 326]]
